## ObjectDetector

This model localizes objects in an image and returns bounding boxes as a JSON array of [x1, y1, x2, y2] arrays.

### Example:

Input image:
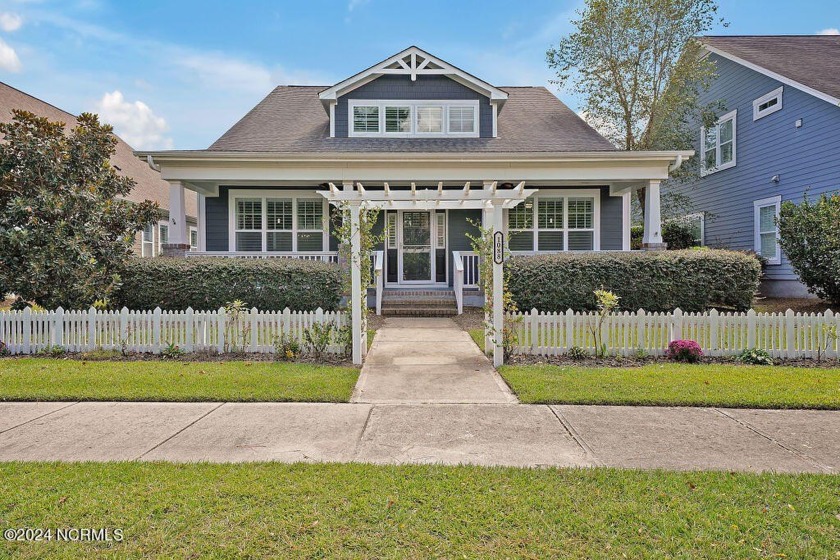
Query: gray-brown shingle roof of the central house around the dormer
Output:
[[209, 86, 615, 153]]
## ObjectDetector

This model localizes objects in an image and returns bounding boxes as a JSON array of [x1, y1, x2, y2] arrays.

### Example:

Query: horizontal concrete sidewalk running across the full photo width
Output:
[[0, 403, 840, 473]]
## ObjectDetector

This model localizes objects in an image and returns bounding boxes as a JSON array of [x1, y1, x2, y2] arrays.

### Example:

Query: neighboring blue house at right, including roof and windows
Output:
[[680, 36, 840, 297]]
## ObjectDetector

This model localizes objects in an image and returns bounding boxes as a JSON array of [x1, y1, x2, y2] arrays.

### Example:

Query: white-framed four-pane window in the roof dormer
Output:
[[349, 100, 479, 138]]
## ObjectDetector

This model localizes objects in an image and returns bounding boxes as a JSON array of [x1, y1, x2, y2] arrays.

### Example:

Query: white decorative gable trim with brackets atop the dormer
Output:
[[318, 47, 508, 107]]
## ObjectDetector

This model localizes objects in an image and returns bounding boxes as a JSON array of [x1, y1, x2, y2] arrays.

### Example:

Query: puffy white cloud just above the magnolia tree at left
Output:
[[96, 90, 173, 150]]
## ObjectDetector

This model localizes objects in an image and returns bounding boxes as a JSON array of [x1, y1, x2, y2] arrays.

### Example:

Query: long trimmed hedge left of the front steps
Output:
[[112, 257, 342, 311]]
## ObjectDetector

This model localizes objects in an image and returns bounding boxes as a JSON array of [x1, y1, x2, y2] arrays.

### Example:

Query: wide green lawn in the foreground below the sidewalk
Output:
[[0, 463, 840, 559]]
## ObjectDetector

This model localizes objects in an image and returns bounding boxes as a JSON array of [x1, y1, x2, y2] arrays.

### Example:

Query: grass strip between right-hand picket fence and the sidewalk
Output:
[[500, 363, 840, 409]]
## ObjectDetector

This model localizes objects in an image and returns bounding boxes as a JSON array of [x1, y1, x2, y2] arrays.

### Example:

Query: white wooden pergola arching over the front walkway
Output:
[[318, 177, 537, 367]]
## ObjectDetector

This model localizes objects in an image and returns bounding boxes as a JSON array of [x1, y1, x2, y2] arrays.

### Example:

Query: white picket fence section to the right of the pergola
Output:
[[508, 309, 840, 358]]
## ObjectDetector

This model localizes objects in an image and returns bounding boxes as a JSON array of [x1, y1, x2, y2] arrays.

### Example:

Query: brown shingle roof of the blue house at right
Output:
[[700, 35, 840, 103]]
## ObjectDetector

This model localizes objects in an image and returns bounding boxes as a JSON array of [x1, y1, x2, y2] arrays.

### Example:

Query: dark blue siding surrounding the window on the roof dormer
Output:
[[335, 75, 493, 138]]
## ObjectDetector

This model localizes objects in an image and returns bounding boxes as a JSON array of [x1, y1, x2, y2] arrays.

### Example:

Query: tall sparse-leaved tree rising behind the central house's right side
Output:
[[547, 0, 723, 213]]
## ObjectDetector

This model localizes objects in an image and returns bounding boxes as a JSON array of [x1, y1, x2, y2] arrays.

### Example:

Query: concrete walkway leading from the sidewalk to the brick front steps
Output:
[[351, 317, 517, 404]]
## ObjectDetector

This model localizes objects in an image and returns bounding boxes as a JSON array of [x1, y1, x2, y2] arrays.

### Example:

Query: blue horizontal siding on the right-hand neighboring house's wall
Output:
[[682, 55, 840, 293]]
